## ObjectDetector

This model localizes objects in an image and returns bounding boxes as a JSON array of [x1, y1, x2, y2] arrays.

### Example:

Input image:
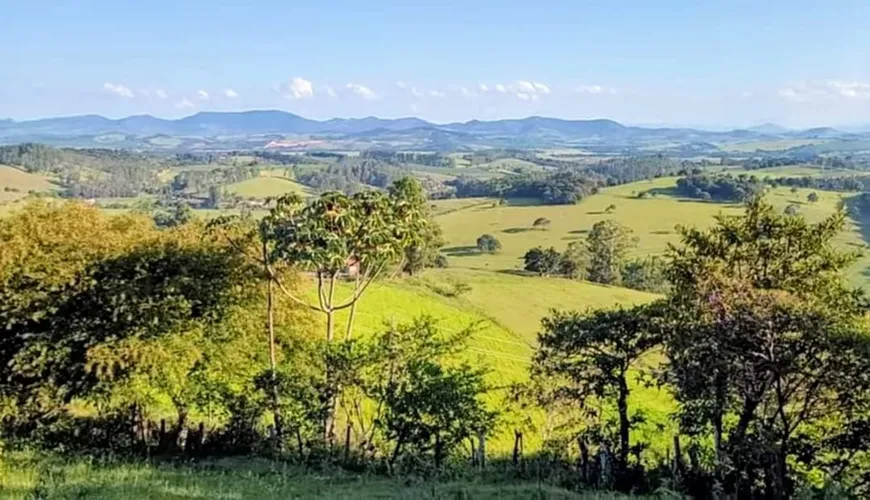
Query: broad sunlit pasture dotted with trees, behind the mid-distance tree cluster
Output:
[[435, 177, 870, 285]]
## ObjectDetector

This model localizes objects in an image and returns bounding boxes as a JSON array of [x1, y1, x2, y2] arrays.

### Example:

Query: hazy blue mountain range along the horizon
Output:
[[0, 110, 870, 150]]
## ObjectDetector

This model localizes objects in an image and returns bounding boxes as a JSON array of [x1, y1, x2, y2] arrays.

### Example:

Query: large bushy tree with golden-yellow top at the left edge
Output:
[[0, 203, 250, 418]]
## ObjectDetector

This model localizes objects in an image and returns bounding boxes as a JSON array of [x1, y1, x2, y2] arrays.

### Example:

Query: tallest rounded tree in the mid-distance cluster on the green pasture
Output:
[[587, 220, 636, 285]]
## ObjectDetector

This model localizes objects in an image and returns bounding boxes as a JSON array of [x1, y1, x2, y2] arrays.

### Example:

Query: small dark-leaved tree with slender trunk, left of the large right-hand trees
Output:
[[534, 306, 660, 471]]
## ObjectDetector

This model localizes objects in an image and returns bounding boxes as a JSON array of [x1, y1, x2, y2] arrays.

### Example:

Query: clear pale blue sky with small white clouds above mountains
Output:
[[0, 0, 870, 128]]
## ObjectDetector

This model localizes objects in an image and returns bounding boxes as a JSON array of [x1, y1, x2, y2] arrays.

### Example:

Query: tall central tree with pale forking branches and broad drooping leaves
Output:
[[263, 178, 429, 441]]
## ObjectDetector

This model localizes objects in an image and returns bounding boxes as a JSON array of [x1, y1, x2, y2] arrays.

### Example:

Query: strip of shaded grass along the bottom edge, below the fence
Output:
[[0, 453, 656, 500]]
